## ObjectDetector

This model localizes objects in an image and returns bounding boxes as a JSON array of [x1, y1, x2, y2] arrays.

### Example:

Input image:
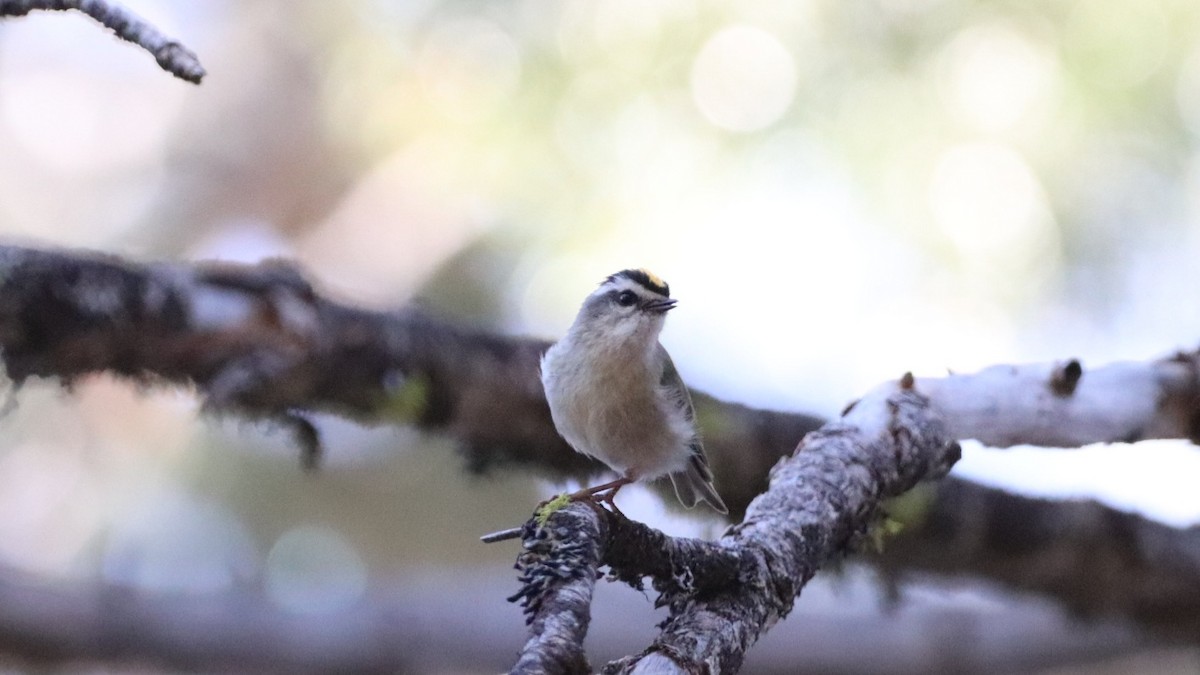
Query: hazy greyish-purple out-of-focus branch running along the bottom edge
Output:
[[0, 554, 1147, 675]]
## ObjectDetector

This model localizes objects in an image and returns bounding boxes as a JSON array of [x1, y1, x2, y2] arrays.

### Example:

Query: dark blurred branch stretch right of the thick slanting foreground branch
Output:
[[872, 480, 1200, 644]]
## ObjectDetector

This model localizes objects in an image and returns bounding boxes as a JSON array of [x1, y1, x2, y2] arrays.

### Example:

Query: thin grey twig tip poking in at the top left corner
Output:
[[0, 0, 205, 84]]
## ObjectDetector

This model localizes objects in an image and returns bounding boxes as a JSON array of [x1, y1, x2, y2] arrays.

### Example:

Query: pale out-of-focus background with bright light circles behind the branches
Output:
[[0, 0, 1200, 673]]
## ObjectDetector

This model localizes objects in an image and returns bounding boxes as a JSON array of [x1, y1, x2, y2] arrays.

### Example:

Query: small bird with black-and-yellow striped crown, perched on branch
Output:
[[541, 269, 728, 513]]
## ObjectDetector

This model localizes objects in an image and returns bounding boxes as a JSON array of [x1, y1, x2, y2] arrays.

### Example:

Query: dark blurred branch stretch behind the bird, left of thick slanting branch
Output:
[[0, 241, 820, 499]]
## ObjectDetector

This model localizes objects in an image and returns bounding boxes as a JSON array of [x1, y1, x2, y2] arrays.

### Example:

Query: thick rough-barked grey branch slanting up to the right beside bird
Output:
[[606, 380, 960, 673]]
